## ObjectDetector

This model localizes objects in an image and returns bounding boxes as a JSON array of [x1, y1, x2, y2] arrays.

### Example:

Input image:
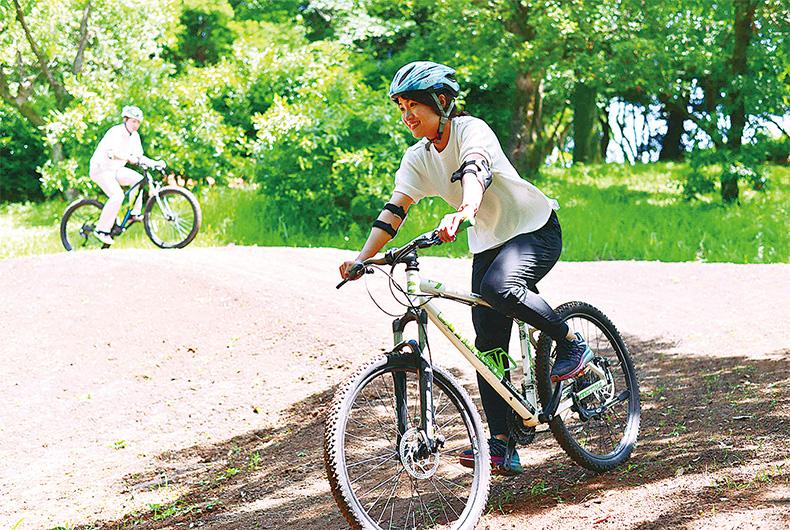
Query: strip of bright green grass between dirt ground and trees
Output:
[[0, 164, 790, 263]]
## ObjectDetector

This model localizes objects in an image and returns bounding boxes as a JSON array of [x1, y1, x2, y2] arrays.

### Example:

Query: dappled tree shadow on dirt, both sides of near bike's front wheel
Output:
[[76, 337, 790, 530]]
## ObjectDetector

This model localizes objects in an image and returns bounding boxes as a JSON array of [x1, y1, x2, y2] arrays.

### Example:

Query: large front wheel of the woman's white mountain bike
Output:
[[324, 354, 491, 530]]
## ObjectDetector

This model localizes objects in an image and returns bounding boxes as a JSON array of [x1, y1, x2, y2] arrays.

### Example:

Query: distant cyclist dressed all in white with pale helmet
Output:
[[90, 106, 165, 245]]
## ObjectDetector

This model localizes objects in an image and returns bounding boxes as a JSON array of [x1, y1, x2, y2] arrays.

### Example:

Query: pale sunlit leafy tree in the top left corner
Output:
[[0, 0, 175, 192]]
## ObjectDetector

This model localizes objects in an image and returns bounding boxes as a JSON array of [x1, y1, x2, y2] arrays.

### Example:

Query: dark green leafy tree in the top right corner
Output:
[[615, 0, 790, 202]]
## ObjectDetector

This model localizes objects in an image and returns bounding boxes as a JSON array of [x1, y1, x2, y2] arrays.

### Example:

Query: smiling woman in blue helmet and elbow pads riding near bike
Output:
[[340, 61, 592, 474]]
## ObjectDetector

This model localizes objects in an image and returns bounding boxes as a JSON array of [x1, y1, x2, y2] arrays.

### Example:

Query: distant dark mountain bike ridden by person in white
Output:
[[60, 163, 201, 251]]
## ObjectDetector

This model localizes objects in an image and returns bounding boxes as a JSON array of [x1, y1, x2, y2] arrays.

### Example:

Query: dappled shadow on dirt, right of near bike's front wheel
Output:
[[489, 337, 790, 529]]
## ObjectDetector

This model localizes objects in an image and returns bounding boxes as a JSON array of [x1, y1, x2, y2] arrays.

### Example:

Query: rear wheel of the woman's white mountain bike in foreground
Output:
[[535, 302, 640, 472]]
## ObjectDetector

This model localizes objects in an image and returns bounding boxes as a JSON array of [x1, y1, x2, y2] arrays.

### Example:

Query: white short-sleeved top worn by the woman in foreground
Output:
[[395, 116, 559, 254]]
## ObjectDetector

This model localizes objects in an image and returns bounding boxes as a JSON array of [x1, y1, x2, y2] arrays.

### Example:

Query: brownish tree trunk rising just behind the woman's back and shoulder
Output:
[[509, 72, 544, 176]]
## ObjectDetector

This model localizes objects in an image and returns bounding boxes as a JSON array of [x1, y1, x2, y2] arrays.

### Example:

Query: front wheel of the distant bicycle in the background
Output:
[[144, 186, 201, 248]]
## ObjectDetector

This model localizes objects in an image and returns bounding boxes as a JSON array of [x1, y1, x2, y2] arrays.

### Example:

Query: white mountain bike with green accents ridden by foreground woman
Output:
[[324, 224, 640, 530]]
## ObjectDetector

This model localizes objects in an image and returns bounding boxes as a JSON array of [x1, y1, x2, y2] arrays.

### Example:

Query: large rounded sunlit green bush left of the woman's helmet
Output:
[[253, 42, 408, 229]]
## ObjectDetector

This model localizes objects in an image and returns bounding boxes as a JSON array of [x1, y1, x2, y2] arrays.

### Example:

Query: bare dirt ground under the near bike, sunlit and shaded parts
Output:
[[0, 247, 790, 530]]
